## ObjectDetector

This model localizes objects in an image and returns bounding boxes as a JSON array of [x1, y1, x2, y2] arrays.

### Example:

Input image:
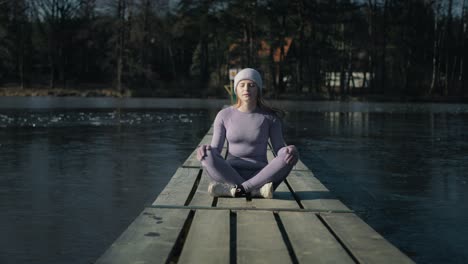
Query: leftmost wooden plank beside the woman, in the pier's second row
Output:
[[153, 168, 200, 205]]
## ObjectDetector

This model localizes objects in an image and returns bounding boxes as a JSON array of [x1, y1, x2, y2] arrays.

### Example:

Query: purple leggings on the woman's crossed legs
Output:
[[201, 147, 293, 192]]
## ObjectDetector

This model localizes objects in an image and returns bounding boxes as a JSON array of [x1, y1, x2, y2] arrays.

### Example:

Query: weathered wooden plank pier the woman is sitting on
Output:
[[96, 125, 413, 264]]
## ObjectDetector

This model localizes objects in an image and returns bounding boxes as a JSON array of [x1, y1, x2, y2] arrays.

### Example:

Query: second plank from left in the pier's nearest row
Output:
[[178, 210, 230, 264]]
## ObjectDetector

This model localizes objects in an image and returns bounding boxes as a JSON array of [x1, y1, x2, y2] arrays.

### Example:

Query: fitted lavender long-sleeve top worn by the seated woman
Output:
[[211, 106, 285, 169]]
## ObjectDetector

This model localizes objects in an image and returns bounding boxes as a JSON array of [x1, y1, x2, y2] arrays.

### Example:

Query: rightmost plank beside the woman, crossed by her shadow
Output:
[[286, 171, 349, 211]]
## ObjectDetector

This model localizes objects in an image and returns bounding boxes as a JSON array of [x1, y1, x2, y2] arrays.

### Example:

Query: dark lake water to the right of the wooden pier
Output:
[[287, 112, 468, 263]]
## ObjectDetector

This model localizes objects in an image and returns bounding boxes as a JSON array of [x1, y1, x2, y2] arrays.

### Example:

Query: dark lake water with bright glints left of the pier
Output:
[[0, 110, 212, 264]]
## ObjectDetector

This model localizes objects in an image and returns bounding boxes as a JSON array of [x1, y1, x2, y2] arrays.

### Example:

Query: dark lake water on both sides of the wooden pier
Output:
[[0, 98, 468, 263]]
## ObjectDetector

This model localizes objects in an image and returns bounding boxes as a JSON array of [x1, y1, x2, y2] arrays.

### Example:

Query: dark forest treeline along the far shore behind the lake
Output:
[[0, 0, 468, 98]]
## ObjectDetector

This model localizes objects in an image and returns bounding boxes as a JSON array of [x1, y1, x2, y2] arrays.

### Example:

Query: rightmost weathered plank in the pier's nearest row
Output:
[[320, 213, 414, 263]]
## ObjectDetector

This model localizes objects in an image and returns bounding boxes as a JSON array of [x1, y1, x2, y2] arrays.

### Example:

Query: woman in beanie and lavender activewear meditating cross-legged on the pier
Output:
[[197, 68, 299, 198]]
